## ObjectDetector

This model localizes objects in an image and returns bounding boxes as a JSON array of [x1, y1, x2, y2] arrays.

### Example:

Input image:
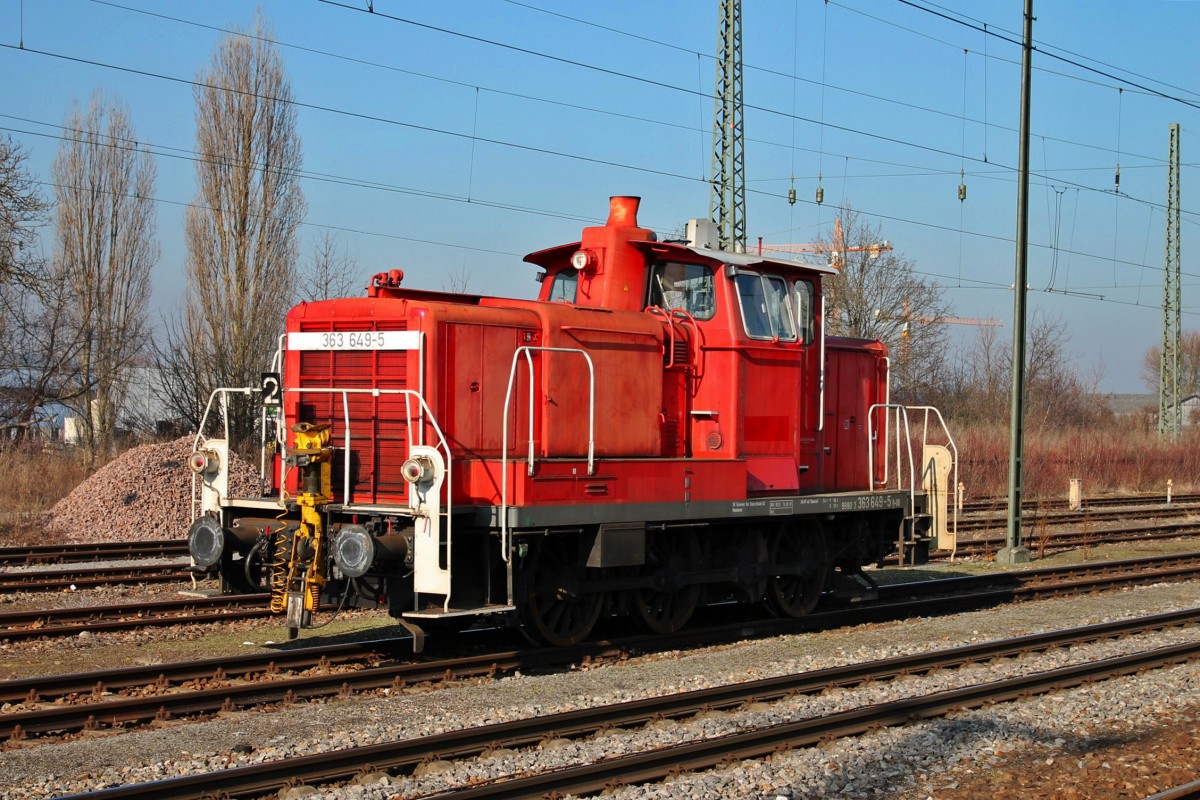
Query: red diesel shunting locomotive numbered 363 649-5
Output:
[[190, 197, 954, 648]]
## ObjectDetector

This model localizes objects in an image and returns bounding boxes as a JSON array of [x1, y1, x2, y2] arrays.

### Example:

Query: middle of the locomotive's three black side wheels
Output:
[[631, 530, 701, 633]]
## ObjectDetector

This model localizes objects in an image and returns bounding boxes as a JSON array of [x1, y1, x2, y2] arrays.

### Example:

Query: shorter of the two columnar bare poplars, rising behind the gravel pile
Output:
[[53, 91, 158, 461]]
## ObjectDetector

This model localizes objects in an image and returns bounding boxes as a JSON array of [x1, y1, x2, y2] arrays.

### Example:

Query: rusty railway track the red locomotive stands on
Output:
[[9, 554, 1200, 739]]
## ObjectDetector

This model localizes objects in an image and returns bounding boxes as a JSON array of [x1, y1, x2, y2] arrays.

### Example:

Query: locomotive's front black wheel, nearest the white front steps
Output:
[[516, 535, 604, 646]]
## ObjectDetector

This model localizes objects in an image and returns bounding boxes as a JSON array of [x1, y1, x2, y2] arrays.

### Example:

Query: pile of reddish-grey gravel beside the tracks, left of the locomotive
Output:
[[44, 437, 265, 542]]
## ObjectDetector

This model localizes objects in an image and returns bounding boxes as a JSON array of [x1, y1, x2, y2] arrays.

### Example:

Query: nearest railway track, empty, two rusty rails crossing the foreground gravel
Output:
[[44, 608, 1200, 800]]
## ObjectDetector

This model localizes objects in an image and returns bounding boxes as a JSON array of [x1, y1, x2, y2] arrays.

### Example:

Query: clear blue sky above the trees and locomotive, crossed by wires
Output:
[[0, 0, 1200, 392]]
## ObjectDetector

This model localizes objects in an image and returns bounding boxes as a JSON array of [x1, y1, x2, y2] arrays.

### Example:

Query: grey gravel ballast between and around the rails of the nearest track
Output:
[[0, 583, 1200, 800]]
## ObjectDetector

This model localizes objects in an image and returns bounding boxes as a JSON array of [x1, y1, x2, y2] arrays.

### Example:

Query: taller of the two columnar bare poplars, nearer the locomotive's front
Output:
[[184, 14, 305, 443]]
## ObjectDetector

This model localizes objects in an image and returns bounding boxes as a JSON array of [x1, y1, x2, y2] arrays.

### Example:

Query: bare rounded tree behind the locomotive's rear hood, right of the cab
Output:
[[823, 209, 948, 402]]
